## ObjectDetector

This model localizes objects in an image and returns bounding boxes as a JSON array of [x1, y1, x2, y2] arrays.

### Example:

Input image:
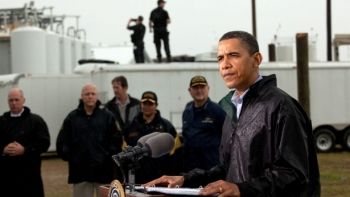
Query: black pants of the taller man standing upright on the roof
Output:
[[154, 29, 171, 62]]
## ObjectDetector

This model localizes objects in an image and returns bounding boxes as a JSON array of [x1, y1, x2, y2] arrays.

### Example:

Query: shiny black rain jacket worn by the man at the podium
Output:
[[185, 75, 320, 197]]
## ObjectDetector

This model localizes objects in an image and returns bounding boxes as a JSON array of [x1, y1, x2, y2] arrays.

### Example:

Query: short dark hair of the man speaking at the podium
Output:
[[219, 31, 259, 54]]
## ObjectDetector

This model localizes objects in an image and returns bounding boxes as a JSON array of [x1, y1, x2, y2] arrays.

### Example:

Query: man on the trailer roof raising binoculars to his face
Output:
[[126, 16, 146, 63]]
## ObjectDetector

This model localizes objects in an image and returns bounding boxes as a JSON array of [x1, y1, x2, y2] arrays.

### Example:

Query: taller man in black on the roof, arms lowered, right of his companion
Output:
[[149, 0, 171, 62]]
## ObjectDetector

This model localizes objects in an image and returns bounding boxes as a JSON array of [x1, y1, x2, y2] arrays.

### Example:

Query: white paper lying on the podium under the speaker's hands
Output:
[[135, 186, 202, 196]]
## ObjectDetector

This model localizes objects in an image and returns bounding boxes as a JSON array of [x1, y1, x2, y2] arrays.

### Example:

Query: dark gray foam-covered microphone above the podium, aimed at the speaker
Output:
[[112, 132, 175, 163]]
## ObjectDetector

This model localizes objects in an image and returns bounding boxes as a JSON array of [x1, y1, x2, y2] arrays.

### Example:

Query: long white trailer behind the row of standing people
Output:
[[0, 62, 350, 152]]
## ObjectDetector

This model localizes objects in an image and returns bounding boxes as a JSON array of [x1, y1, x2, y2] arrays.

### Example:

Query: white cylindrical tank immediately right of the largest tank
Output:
[[46, 32, 61, 74]]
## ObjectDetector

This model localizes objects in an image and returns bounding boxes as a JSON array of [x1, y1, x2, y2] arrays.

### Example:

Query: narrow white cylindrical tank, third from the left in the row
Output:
[[60, 36, 73, 74]]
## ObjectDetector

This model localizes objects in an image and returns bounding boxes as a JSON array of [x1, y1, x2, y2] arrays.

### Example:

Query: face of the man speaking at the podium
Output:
[[217, 39, 262, 91]]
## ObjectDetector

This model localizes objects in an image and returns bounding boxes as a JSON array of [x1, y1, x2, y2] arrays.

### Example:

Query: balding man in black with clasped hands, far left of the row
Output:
[[0, 88, 50, 197]]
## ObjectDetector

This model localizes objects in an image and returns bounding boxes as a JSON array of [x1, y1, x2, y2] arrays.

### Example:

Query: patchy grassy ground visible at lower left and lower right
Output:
[[42, 152, 350, 197]]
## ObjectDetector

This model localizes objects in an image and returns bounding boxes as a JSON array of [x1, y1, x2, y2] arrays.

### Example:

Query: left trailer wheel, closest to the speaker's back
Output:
[[315, 128, 335, 153]]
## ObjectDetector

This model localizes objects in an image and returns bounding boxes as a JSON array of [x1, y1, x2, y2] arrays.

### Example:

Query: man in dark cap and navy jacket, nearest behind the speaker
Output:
[[182, 75, 226, 172]]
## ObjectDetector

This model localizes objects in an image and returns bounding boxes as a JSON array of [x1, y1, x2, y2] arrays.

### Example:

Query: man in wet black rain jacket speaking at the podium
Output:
[[147, 31, 320, 197]]
